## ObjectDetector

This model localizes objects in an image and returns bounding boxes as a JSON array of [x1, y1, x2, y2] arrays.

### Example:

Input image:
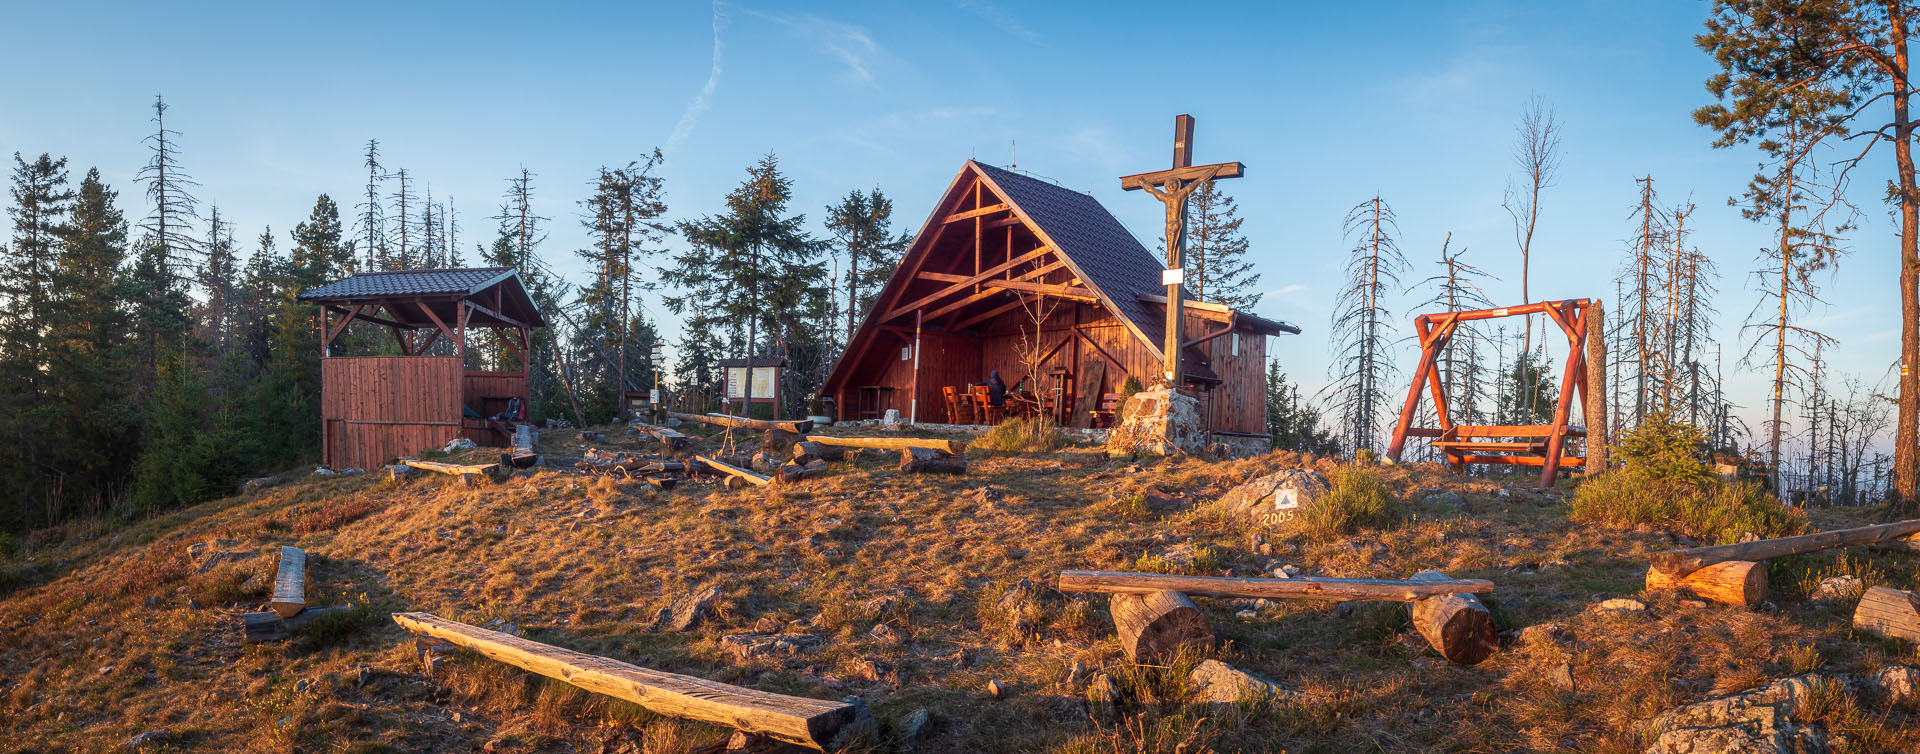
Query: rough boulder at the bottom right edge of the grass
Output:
[[1645, 675, 1839, 754]]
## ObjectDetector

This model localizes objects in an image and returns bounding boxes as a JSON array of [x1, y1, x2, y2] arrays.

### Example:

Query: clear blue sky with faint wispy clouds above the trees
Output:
[[0, 0, 1899, 443]]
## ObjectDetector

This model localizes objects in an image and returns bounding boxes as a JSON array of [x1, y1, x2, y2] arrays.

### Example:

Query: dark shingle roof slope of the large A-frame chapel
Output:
[[973, 161, 1167, 358]]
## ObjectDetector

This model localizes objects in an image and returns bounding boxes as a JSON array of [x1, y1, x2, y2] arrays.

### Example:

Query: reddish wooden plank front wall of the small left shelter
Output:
[[321, 357, 461, 468]]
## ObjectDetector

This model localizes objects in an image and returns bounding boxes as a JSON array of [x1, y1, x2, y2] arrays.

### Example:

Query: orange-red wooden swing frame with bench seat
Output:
[[1386, 299, 1590, 487]]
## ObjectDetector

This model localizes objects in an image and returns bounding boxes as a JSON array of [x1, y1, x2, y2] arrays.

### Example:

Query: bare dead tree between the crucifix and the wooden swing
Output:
[[1321, 196, 1407, 451]]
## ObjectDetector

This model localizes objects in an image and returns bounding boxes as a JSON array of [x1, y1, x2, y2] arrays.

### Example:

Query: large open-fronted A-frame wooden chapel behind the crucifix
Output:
[[822, 161, 1300, 439]]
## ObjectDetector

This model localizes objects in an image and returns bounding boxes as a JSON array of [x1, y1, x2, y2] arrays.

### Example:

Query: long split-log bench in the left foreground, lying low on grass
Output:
[[394, 612, 870, 750]]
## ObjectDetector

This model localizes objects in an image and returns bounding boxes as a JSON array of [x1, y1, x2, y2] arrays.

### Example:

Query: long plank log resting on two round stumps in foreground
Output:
[[1058, 570, 1494, 602]]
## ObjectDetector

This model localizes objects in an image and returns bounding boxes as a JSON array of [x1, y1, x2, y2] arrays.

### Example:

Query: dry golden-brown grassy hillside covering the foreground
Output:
[[0, 425, 1920, 752]]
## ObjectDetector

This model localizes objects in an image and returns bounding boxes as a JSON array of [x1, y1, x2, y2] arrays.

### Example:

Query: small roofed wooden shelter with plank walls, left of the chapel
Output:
[[300, 267, 547, 468]]
